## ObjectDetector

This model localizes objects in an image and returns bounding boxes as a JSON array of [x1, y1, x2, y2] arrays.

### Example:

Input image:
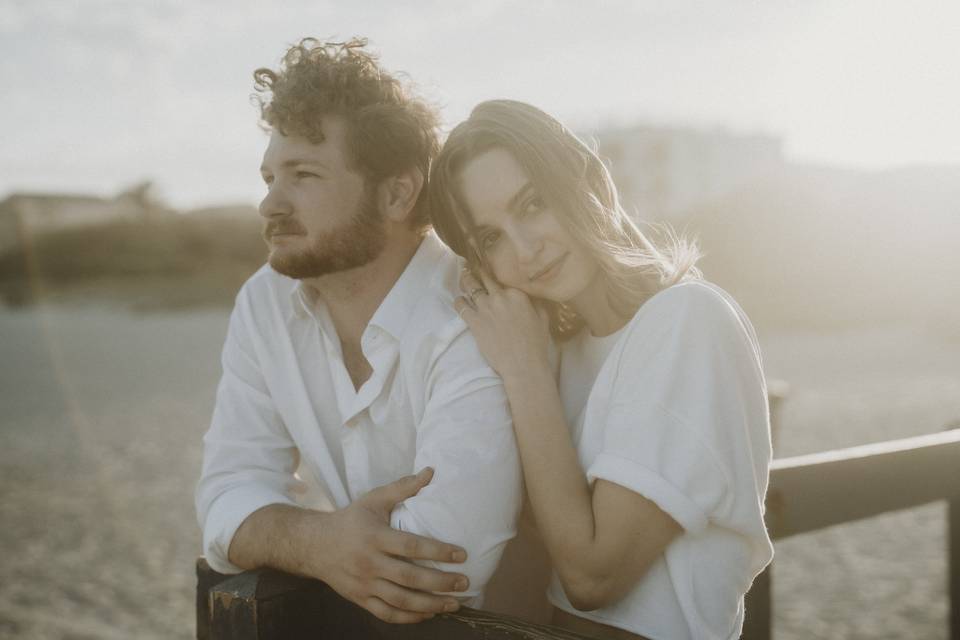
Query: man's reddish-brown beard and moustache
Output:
[[263, 188, 386, 279]]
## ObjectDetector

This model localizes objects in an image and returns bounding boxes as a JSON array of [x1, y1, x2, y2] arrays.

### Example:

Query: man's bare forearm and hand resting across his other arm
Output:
[[230, 468, 469, 623]]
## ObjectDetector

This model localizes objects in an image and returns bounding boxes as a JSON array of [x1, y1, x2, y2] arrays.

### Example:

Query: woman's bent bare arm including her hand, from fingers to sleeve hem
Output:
[[457, 280, 682, 610]]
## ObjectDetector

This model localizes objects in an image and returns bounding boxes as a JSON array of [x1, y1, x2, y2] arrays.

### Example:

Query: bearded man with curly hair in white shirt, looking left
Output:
[[196, 39, 521, 622]]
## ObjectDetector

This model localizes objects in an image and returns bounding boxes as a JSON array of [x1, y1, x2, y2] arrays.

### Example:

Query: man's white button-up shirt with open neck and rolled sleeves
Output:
[[196, 233, 521, 596]]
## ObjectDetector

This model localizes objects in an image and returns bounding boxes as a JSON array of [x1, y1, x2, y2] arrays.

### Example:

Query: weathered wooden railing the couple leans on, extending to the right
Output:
[[197, 429, 960, 640]]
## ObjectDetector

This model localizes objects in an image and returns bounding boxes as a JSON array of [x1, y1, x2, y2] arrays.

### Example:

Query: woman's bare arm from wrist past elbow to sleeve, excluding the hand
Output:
[[504, 360, 683, 611]]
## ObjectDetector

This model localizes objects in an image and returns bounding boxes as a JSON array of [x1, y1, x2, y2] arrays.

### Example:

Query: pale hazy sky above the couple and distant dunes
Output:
[[0, 0, 960, 206]]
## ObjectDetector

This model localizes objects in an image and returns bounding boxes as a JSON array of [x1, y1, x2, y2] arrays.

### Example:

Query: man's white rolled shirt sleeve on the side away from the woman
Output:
[[195, 298, 297, 573]]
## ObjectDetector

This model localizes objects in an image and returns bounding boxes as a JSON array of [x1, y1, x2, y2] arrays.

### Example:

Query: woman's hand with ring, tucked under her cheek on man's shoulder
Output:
[[454, 270, 550, 380]]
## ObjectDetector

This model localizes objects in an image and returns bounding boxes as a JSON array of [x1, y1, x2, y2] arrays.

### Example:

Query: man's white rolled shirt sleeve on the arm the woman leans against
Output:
[[391, 333, 522, 597]]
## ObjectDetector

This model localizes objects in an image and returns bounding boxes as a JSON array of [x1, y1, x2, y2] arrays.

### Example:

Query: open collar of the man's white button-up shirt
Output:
[[290, 229, 445, 340]]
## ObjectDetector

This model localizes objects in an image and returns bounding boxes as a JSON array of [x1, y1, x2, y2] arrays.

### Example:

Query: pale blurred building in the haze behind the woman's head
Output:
[[592, 126, 784, 220]]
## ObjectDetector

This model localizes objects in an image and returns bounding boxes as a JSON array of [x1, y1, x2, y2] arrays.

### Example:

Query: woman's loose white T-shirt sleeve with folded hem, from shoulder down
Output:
[[587, 284, 770, 534]]
